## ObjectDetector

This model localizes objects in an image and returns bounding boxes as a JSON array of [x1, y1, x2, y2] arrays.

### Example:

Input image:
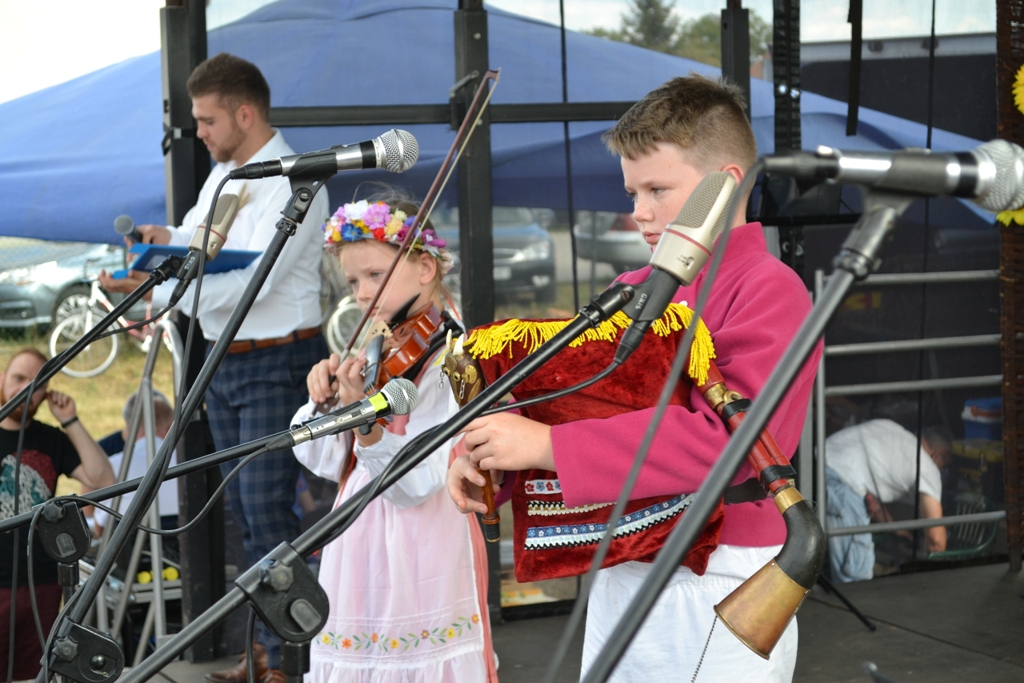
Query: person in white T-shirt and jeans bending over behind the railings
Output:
[[825, 420, 950, 582]]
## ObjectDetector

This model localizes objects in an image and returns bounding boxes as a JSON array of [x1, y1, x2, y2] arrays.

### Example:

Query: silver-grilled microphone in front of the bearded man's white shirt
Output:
[[228, 128, 420, 179]]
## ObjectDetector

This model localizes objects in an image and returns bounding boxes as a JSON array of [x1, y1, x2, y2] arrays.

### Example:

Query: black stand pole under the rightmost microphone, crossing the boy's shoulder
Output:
[[583, 190, 921, 683]]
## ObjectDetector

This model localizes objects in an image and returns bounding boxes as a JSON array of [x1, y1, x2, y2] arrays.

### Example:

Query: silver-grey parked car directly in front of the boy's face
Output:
[[572, 211, 650, 273]]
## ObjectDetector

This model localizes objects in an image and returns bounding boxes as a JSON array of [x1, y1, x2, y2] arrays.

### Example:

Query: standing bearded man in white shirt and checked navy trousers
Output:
[[100, 53, 329, 683]]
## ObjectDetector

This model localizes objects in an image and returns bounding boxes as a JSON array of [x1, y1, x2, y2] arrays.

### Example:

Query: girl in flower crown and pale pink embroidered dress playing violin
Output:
[[293, 193, 498, 683]]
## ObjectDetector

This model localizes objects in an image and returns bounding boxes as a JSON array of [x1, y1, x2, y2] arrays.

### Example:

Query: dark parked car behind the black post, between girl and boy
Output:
[[430, 207, 557, 302]]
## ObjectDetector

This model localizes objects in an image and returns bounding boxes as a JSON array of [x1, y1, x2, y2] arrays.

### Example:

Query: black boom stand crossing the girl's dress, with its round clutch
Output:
[[120, 284, 634, 683]]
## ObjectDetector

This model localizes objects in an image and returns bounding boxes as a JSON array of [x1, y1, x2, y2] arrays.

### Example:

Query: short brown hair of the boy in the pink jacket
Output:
[[603, 74, 758, 172]]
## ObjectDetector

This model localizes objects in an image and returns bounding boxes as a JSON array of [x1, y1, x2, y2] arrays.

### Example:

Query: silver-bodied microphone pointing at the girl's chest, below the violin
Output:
[[266, 377, 419, 451]]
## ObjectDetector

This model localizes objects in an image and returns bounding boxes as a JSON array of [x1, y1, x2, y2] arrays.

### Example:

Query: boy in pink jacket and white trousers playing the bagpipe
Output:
[[449, 75, 820, 683]]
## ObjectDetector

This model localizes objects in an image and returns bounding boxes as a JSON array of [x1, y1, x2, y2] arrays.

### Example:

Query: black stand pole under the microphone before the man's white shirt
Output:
[[36, 168, 327, 683]]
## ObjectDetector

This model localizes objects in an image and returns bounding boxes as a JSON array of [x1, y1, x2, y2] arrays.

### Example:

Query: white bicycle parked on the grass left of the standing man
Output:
[[49, 280, 166, 378]]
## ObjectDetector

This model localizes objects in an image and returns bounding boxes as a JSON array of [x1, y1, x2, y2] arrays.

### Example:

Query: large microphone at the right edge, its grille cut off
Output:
[[764, 140, 1024, 212]]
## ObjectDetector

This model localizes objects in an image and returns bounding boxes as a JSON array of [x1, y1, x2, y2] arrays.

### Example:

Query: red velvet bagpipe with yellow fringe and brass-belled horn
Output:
[[442, 303, 825, 657]]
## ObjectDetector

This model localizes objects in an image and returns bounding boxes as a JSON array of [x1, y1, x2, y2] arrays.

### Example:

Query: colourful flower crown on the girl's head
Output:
[[324, 200, 452, 272]]
